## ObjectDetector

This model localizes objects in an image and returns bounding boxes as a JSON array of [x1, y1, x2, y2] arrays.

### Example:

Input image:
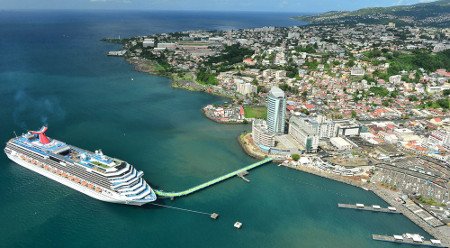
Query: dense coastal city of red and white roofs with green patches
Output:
[[107, 18, 450, 244]]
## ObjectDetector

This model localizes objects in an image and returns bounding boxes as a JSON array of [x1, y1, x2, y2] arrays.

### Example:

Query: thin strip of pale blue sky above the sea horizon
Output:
[[0, 0, 431, 13]]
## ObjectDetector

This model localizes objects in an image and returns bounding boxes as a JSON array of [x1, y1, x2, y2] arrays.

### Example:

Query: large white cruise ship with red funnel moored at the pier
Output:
[[5, 126, 156, 206]]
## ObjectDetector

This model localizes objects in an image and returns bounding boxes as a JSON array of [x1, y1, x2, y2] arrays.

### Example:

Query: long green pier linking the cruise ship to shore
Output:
[[154, 158, 272, 198]]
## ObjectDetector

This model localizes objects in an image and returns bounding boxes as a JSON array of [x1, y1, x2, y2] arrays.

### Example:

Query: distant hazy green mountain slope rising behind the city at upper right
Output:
[[297, 0, 450, 27]]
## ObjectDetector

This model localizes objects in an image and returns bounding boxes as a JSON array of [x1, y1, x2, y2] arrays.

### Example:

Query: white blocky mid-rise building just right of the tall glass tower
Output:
[[289, 116, 320, 153]]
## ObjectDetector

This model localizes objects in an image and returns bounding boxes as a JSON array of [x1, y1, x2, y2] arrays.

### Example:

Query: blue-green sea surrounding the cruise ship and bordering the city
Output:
[[0, 11, 429, 248]]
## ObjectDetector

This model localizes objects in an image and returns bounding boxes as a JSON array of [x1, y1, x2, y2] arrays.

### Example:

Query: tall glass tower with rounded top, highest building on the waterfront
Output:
[[267, 86, 286, 134]]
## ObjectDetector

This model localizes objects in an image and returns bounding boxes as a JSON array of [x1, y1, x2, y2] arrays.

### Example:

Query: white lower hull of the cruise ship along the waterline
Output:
[[7, 154, 151, 206]]
